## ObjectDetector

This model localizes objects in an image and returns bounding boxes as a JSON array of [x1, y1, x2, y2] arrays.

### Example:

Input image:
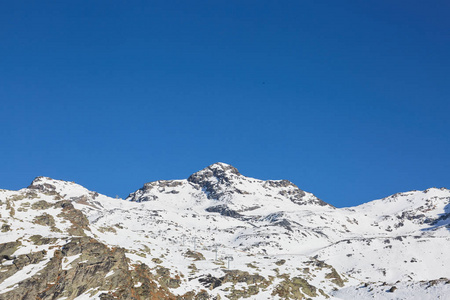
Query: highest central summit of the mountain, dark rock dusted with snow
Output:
[[127, 163, 332, 212]]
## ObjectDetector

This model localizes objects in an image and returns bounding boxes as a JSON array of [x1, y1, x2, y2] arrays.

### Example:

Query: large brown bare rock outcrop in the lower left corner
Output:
[[0, 237, 183, 300]]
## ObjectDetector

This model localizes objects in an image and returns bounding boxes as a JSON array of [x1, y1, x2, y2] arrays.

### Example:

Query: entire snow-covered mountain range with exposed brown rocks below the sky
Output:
[[0, 163, 450, 299]]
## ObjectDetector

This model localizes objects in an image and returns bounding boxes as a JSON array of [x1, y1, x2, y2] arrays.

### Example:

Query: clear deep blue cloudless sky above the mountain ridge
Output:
[[0, 1, 450, 207]]
